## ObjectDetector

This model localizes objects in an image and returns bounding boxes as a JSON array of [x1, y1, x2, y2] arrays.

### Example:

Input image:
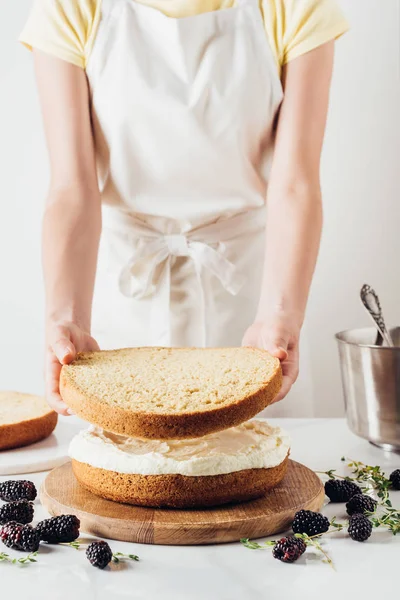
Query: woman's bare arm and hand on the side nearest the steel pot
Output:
[[243, 42, 334, 400]]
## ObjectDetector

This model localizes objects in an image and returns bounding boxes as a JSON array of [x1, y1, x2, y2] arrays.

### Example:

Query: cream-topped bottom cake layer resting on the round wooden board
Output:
[[70, 420, 290, 508]]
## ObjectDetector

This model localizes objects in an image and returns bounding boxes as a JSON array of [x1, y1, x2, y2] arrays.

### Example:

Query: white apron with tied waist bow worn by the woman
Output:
[[87, 0, 311, 416]]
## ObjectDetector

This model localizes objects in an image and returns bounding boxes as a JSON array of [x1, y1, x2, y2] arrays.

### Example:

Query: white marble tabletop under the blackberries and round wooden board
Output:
[[0, 419, 400, 600]]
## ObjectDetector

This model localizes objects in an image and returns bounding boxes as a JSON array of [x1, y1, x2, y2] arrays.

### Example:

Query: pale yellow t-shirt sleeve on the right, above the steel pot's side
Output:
[[264, 0, 349, 67]]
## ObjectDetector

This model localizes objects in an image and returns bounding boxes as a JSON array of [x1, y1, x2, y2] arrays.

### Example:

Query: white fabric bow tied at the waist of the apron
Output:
[[103, 207, 265, 347]]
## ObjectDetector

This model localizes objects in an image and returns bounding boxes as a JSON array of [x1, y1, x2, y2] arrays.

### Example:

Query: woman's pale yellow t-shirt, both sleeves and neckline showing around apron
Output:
[[19, 0, 348, 70]]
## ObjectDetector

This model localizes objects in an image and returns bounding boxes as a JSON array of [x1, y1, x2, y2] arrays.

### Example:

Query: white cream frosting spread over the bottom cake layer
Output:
[[69, 420, 290, 477]]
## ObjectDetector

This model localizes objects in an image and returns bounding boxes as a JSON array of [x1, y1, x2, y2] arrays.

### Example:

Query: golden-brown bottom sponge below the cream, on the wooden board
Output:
[[72, 455, 289, 508]]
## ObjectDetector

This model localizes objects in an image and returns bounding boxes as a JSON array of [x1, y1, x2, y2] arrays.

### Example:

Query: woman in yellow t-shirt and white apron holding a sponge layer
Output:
[[21, 0, 347, 414]]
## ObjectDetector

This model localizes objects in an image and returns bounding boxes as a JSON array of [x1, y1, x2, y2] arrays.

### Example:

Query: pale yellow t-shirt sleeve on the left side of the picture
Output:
[[19, 0, 100, 69]]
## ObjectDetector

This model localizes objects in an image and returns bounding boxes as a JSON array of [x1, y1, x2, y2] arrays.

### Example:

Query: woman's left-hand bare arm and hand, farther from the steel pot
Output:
[[34, 50, 101, 414]]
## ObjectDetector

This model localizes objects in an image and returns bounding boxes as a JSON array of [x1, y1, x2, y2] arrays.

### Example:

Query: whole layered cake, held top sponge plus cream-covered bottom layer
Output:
[[60, 348, 289, 508]]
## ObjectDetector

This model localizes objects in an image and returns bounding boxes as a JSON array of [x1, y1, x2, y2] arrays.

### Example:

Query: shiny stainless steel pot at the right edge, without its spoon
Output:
[[336, 327, 400, 452]]
